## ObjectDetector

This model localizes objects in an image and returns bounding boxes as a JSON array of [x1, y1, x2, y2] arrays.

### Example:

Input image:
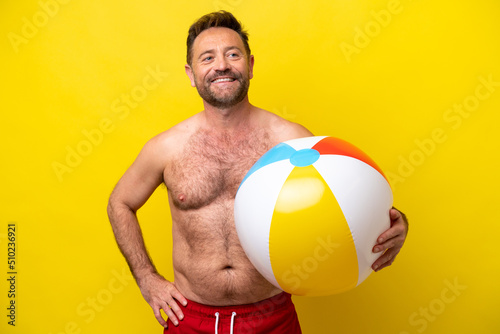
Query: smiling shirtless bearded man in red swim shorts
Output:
[[108, 12, 407, 333]]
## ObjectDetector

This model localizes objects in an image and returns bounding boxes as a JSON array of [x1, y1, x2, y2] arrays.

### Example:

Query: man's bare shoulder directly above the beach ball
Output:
[[259, 109, 313, 142]]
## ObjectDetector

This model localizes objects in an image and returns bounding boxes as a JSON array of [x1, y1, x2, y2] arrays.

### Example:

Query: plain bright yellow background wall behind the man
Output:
[[0, 0, 500, 334]]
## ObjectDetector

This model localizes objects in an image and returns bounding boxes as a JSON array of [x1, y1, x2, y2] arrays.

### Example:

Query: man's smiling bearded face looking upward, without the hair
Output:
[[186, 28, 253, 109]]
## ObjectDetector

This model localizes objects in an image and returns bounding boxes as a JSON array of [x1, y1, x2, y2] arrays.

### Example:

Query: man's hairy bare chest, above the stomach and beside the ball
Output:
[[165, 132, 272, 210]]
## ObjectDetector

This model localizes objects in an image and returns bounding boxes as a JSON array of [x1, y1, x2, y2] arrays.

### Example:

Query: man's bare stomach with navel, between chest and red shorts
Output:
[[172, 206, 281, 306]]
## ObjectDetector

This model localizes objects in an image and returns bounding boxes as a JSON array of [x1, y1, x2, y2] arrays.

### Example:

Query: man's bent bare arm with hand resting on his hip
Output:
[[108, 137, 187, 327]]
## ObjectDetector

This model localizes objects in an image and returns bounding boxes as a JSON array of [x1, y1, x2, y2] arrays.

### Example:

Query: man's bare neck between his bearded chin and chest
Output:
[[203, 96, 254, 131]]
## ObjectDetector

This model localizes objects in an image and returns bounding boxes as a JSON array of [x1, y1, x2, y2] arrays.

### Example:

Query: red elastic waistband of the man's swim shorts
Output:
[[186, 292, 294, 318]]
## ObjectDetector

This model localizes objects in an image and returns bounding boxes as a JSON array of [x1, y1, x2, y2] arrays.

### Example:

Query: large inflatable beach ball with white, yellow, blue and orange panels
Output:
[[234, 137, 392, 296]]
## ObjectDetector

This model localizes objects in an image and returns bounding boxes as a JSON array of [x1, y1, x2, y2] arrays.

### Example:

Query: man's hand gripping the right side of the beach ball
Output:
[[372, 207, 408, 271]]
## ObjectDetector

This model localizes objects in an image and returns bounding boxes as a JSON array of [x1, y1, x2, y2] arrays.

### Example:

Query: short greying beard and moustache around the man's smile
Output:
[[195, 70, 250, 109]]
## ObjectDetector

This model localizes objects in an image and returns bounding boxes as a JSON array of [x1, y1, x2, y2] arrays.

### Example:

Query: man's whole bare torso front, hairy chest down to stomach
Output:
[[164, 126, 282, 305]]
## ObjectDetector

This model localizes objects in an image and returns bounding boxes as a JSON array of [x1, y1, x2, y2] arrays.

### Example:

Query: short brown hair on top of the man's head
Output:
[[186, 10, 250, 65]]
